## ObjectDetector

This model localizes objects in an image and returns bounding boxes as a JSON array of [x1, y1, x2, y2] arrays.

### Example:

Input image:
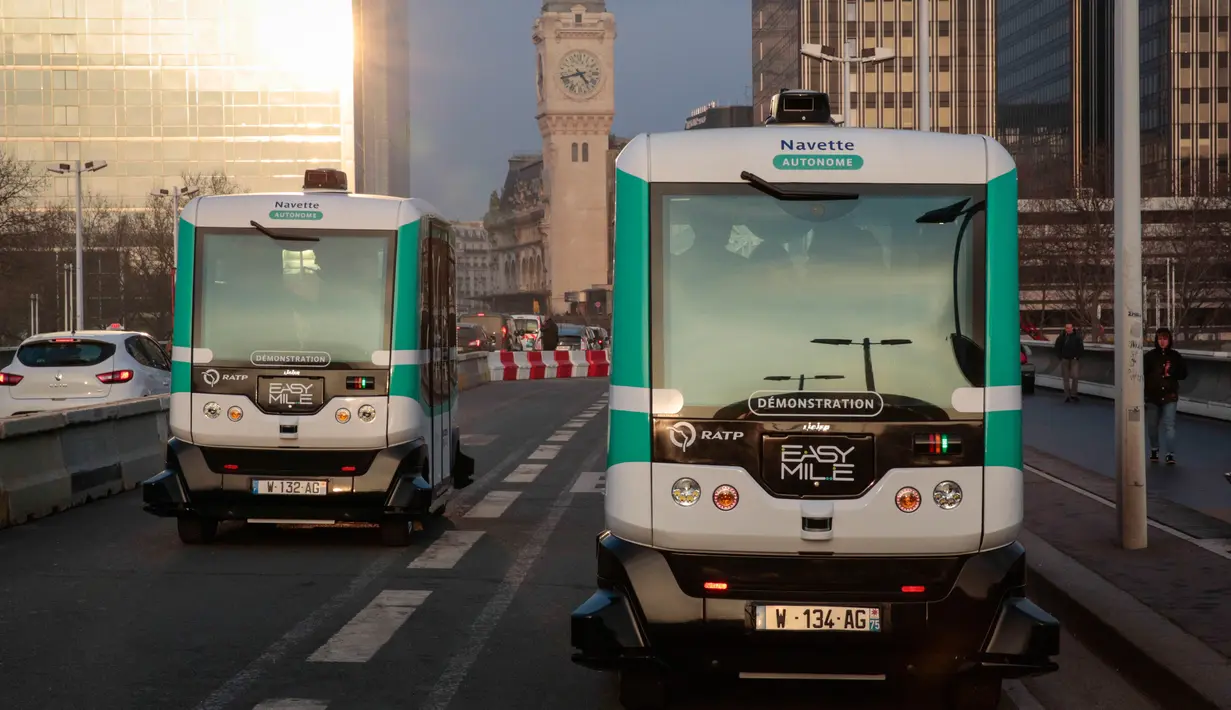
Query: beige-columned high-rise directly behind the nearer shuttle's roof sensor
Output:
[[752, 0, 996, 134]]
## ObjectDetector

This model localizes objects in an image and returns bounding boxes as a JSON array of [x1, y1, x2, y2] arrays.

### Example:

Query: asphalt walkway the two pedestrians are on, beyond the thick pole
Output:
[[1022, 388, 1231, 521]]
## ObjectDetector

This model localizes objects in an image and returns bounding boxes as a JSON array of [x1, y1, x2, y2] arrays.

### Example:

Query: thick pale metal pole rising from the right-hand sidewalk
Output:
[[1115, 0, 1147, 550]]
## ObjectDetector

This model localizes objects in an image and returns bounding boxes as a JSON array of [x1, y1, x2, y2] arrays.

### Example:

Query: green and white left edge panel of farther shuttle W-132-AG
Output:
[[169, 211, 197, 443]]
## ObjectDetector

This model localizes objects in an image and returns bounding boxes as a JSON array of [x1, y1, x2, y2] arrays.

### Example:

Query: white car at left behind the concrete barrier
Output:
[[0, 330, 171, 418]]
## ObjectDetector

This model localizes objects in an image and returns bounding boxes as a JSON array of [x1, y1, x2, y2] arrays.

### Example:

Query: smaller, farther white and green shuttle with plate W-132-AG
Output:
[[143, 170, 474, 545]]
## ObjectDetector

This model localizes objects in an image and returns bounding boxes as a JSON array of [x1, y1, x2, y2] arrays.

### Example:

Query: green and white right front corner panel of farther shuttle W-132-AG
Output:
[[388, 220, 427, 447]]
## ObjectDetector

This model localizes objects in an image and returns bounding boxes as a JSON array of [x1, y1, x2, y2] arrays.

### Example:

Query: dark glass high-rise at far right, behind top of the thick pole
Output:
[[997, 0, 1231, 197]]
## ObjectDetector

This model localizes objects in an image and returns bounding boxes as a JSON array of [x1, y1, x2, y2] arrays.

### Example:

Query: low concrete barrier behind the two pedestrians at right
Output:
[[1022, 340, 1231, 421]]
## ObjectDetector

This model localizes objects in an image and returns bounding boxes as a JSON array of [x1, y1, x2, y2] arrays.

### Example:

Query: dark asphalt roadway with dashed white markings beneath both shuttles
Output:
[[0, 380, 1153, 710]]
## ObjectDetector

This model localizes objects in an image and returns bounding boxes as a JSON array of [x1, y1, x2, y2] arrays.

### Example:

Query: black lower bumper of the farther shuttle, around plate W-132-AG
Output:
[[142, 439, 474, 523]]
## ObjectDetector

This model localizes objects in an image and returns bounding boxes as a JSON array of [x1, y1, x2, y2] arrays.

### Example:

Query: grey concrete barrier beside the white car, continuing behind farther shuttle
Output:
[[0, 353, 489, 528]]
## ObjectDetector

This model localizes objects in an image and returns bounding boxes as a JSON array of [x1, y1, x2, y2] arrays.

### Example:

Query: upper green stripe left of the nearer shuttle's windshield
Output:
[[611, 170, 650, 388]]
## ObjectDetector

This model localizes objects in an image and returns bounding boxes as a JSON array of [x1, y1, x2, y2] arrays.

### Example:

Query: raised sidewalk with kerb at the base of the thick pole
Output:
[[1022, 447, 1231, 710]]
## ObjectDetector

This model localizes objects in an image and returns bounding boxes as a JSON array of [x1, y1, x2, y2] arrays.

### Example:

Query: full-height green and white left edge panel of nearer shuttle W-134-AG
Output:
[[604, 152, 654, 544]]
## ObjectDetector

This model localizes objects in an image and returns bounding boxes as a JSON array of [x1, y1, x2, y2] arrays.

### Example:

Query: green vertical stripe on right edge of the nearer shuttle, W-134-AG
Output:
[[985, 164, 1022, 469]]
